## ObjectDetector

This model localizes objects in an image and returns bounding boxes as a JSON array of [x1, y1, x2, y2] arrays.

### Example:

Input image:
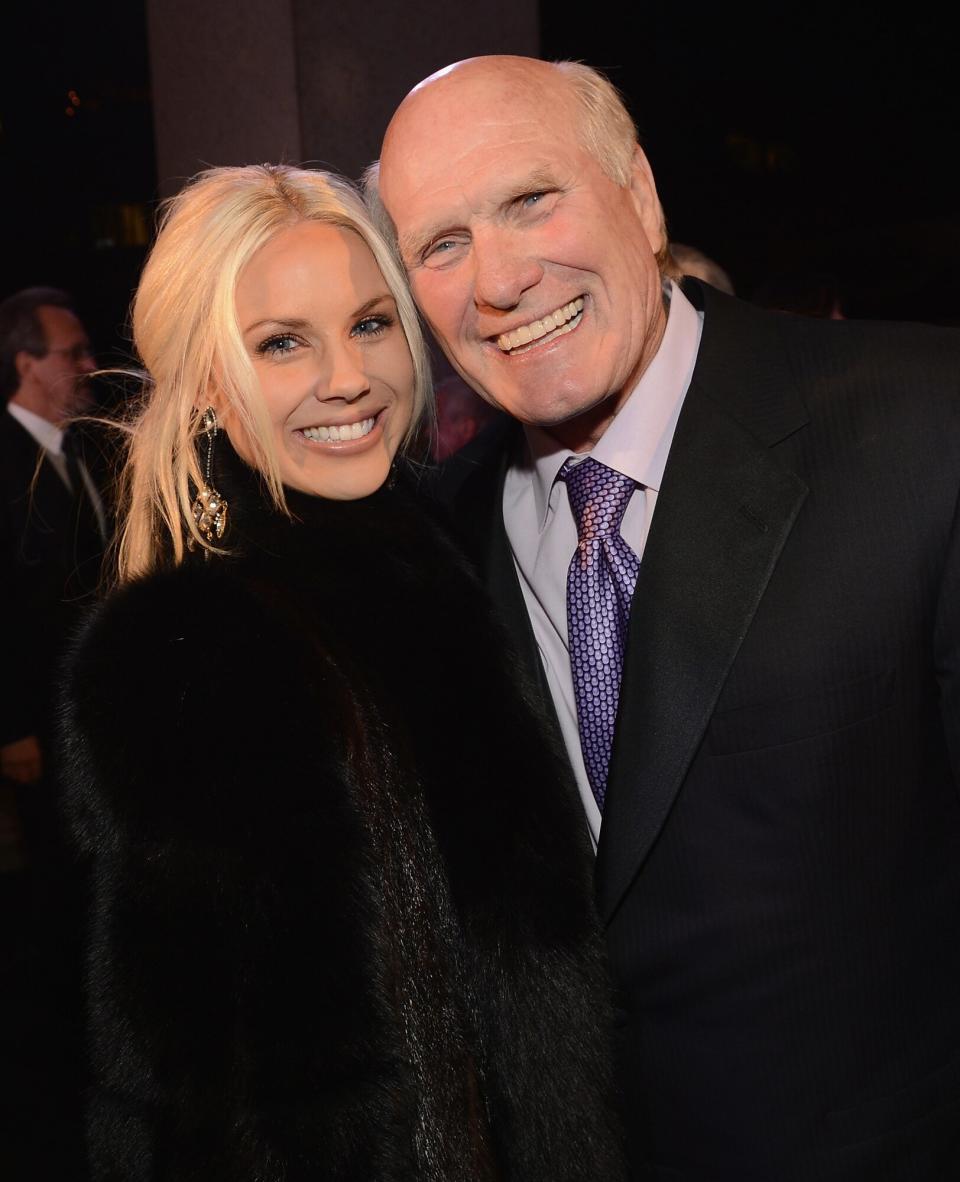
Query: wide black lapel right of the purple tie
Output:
[[597, 288, 806, 921]]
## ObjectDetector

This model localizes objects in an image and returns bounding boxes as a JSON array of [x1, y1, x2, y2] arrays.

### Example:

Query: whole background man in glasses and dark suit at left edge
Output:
[[0, 287, 108, 1180]]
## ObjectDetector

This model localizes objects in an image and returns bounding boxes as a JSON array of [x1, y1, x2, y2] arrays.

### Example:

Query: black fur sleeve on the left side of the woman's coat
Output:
[[63, 572, 401, 1182]]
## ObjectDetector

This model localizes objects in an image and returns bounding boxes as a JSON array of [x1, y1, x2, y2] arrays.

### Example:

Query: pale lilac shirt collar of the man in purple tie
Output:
[[524, 280, 703, 530]]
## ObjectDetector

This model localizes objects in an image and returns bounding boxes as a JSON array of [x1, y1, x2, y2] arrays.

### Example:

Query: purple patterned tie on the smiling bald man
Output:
[[560, 457, 640, 812]]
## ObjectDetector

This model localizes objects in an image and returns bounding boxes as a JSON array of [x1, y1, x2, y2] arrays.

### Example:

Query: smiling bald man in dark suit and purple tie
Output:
[[371, 58, 960, 1182]]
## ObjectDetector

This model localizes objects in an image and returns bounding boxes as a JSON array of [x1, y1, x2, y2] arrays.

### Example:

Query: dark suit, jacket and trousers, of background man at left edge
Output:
[[0, 407, 104, 1182]]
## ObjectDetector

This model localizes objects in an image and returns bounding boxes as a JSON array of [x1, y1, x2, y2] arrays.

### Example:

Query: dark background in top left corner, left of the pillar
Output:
[[0, 0, 157, 361]]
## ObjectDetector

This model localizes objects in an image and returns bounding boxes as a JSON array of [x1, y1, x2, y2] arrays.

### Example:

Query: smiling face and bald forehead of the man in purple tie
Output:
[[381, 63, 666, 449]]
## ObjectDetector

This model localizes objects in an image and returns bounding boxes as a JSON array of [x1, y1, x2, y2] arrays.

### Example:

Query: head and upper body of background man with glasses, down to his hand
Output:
[[0, 287, 106, 782]]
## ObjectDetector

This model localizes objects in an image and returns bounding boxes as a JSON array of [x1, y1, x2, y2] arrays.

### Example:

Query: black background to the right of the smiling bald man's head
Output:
[[541, 11, 960, 322]]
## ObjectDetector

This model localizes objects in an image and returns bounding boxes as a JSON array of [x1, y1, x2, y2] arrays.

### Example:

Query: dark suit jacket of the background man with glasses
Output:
[[0, 407, 103, 743]]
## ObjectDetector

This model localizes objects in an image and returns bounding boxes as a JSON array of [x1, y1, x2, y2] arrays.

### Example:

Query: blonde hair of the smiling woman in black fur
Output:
[[117, 164, 430, 582]]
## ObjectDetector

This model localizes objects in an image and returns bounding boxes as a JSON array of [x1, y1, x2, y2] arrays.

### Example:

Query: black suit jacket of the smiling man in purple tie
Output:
[[445, 284, 960, 1182]]
